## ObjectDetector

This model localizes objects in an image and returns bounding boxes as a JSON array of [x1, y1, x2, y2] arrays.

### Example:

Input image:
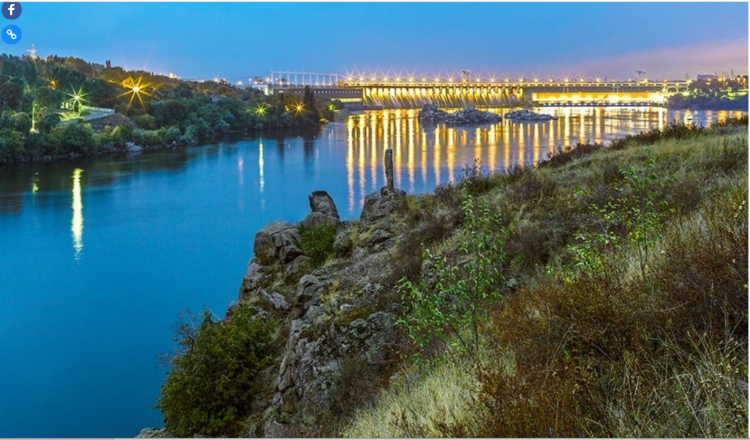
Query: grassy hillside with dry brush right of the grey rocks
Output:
[[338, 119, 748, 437]]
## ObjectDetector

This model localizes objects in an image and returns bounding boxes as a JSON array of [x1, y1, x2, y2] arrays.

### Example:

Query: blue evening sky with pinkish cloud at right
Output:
[[11, 2, 748, 80]]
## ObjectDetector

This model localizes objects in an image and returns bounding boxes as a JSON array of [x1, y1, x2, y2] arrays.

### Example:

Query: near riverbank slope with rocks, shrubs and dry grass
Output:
[[150, 118, 747, 437]]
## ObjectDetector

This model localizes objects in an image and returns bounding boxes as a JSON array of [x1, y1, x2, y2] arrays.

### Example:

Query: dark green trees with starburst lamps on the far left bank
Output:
[[0, 54, 341, 164]]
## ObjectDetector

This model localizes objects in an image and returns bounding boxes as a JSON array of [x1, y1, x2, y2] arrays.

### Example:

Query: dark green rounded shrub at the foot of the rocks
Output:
[[157, 307, 272, 437]]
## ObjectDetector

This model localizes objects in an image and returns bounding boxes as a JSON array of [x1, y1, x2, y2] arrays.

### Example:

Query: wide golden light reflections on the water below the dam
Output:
[[334, 107, 742, 213]]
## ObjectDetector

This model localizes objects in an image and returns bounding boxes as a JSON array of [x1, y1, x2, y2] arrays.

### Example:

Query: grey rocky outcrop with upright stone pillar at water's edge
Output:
[[228, 151, 406, 437]]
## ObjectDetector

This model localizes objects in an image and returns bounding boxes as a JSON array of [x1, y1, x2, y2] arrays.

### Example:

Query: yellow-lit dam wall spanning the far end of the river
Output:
[[340, 81, 689, 109]]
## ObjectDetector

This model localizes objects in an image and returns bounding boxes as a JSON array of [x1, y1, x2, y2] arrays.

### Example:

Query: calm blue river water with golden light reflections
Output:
[[0, 108, 736, 437]]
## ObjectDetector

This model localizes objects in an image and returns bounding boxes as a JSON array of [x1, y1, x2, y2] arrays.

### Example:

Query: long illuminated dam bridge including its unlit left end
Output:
[[266, 72, 690, 109]]
